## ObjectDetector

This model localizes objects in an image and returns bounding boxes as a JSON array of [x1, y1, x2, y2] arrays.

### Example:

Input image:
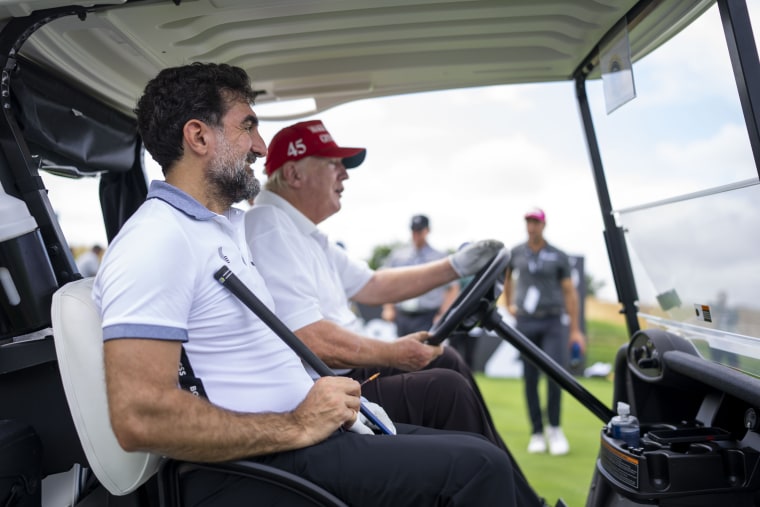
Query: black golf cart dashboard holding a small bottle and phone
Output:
[[597, 329, 760, 505]]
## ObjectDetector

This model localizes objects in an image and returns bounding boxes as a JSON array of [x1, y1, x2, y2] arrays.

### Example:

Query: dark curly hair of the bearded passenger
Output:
[[135, 62, 256, 175]]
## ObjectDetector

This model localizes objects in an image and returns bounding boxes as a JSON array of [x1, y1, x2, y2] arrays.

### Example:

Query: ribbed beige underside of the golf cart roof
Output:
[[0, 0, 713, 119]]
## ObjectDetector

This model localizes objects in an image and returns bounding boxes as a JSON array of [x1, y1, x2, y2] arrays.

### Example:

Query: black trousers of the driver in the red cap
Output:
[[347, 347, 541, 506]]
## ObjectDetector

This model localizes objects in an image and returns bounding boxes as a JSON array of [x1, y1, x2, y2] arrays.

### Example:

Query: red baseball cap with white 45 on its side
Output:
[[264, 120, 367, 176]]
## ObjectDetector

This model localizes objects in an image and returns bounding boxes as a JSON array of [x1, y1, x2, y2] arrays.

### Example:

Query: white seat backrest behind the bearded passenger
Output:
[[51, 278, 162, 495]]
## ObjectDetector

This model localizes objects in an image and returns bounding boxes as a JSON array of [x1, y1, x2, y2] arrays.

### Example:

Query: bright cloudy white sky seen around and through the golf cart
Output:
[[45, 3, 760, 301]]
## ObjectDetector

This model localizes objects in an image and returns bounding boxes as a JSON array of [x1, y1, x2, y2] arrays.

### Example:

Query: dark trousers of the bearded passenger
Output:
[[183, 424, 541, 507]]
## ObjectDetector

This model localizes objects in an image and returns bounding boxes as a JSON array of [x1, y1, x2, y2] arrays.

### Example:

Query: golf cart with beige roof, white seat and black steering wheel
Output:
[[0, 0, 760, 507]]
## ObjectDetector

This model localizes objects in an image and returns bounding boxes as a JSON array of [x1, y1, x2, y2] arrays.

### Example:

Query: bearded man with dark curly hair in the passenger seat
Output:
[[93, 63, 539, 507]]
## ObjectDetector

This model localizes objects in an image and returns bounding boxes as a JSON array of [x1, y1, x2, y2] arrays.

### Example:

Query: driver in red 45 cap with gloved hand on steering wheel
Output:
[[245, 120, 540, 503]]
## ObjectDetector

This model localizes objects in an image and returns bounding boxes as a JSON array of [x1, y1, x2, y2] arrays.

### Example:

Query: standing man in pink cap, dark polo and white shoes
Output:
[[504, 208, 586, 455]]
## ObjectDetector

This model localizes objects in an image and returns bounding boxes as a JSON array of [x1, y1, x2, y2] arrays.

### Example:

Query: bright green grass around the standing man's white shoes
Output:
[[477, 321, 627, 507]]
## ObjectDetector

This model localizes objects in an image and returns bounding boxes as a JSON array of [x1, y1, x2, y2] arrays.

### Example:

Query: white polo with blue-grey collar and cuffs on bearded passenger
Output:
[[93, 181, 313, 412]]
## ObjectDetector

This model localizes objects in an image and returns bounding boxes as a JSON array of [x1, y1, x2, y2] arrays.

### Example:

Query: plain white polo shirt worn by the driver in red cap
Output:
[[245, 190, 373, 331]]
